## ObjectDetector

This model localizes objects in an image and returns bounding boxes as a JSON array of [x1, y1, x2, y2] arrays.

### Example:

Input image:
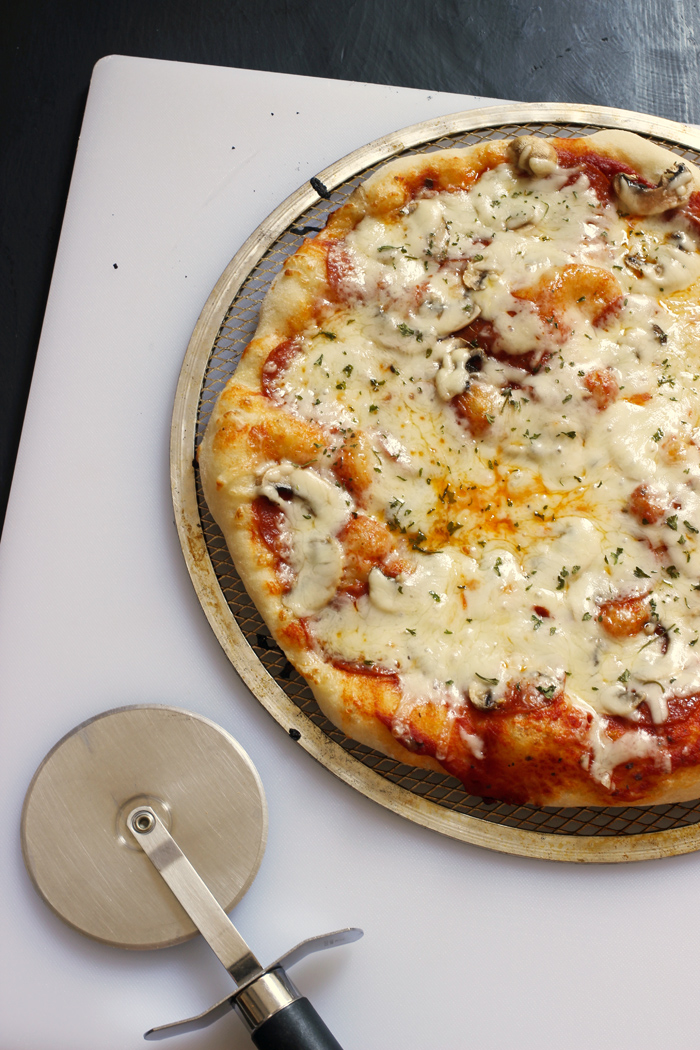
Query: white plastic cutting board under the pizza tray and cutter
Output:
[[0, 56, 700, 1050]]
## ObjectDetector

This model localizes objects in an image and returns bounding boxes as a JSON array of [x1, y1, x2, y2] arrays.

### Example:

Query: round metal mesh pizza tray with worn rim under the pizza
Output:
[[171, 104, 700, 862]]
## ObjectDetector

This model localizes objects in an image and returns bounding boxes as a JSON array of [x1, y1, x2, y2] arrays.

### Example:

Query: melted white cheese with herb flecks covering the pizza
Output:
[[260, 157, 700, 786]]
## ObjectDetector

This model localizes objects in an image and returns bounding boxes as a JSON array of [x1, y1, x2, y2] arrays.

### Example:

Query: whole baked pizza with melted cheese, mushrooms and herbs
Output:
[[198, 131, 700, 805]]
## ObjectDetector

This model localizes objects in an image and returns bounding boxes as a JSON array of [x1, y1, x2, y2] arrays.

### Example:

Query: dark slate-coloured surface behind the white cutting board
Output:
[[0, 0, 700, 529]]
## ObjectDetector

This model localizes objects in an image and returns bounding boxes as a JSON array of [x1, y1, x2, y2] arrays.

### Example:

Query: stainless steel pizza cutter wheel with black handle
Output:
[[22, 705, 362, 1050]]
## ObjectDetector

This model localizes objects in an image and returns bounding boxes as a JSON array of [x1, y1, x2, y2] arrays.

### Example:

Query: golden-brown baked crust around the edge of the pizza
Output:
[[198, 131, 700, 805]]
